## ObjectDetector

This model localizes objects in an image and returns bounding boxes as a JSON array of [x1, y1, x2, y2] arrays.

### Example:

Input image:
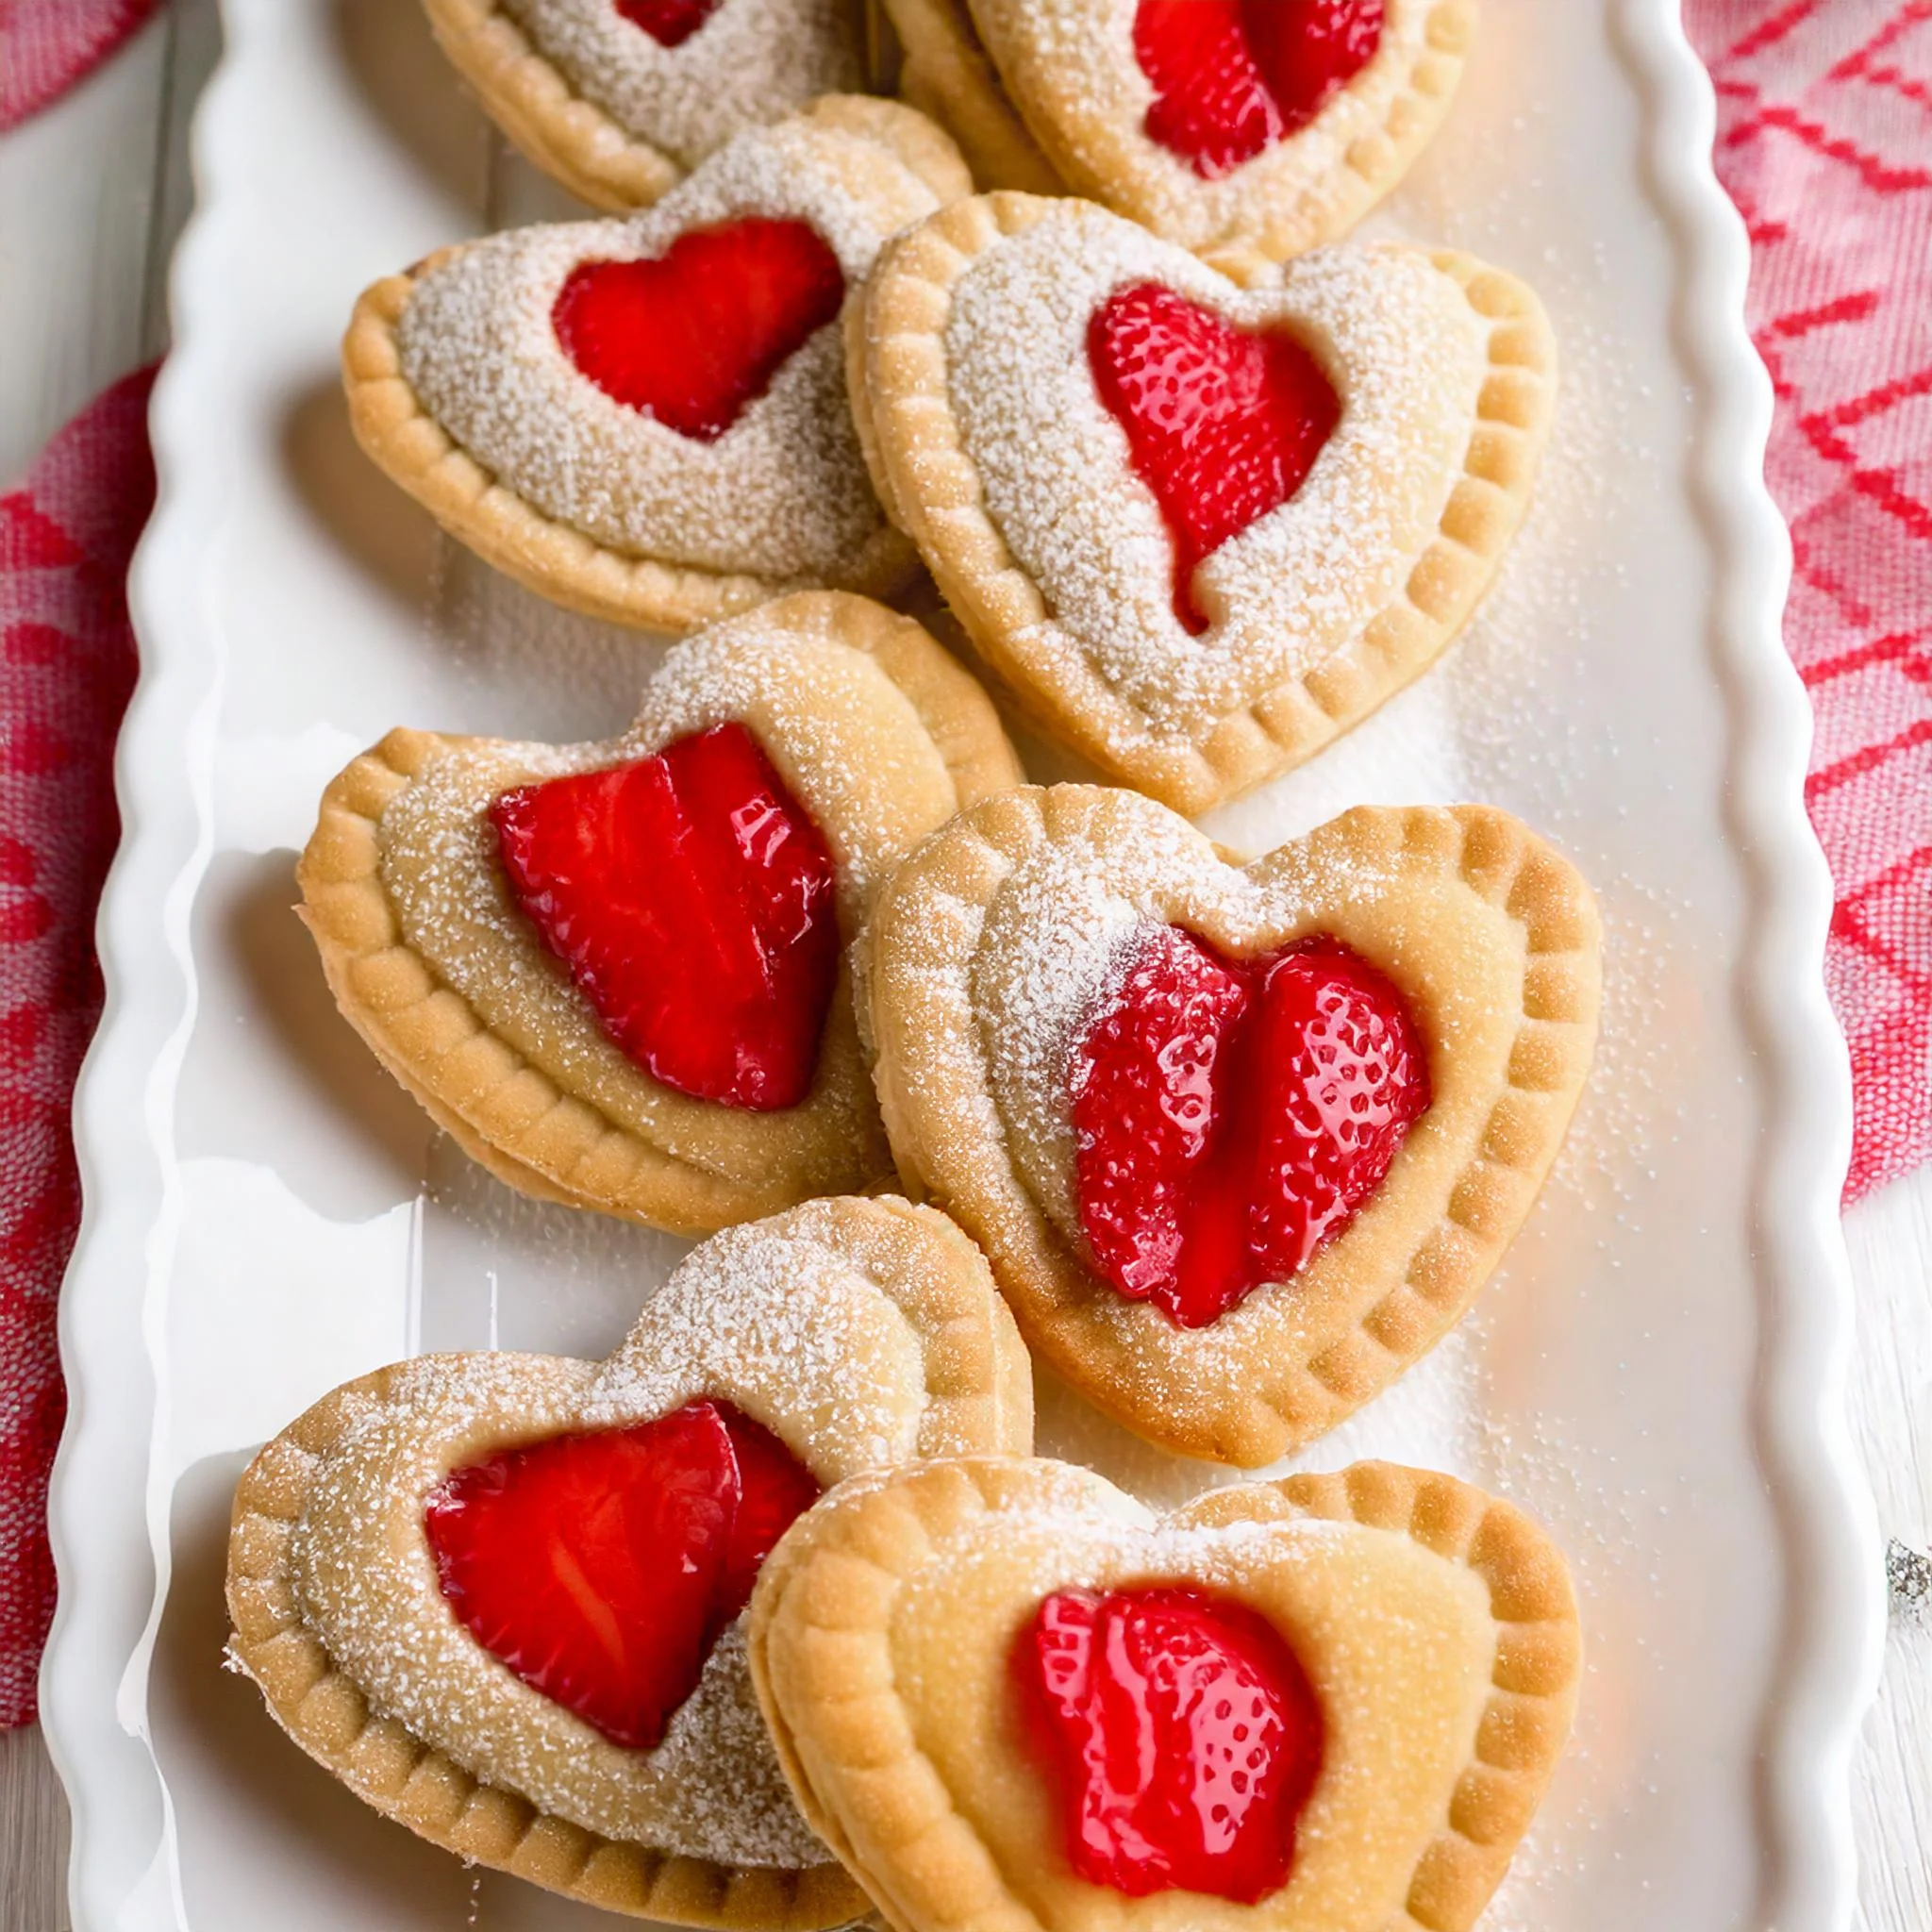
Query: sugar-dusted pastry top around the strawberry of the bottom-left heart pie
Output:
[[288, 1204, 974, 1866]]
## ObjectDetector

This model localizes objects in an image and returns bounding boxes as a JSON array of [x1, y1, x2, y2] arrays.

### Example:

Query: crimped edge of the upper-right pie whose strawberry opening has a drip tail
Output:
[[848, 193, 1556, 817]]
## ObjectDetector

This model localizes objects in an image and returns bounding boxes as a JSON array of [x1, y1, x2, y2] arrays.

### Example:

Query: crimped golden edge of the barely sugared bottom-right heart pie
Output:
[[750, 1457, 1582, 1932]]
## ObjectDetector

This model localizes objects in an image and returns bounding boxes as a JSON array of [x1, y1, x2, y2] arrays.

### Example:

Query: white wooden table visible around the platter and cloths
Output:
[[0, 0, 1932, 1932]]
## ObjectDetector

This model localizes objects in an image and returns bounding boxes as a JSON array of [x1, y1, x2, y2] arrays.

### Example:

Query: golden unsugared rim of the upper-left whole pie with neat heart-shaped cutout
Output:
[[341, 99, 972, 632]]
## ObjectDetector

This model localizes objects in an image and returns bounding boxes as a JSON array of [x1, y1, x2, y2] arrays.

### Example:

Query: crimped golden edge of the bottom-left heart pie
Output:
[[226, 1198, 1032, 1932]]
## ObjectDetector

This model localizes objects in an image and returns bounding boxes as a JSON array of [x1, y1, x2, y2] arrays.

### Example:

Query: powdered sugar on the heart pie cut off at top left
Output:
[[498, 0, 863, 168]]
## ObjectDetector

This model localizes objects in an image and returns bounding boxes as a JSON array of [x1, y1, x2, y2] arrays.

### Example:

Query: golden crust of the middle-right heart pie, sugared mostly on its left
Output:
[[859, 784, 1600, 1468]]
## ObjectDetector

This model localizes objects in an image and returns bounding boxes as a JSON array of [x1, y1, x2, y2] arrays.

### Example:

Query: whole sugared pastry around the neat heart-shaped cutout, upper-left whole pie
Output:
[[341, 96, 970, 632]]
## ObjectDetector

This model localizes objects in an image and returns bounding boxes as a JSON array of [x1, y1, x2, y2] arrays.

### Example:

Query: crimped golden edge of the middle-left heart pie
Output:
[[295, 591, 1020, 1235]]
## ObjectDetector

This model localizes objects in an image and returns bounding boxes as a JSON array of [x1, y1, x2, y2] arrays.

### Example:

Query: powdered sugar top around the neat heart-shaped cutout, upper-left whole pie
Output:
[[398, 122, 939, 583]]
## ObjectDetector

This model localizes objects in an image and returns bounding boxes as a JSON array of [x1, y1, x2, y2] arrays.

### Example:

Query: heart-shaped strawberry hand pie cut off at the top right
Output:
[[972, 0, 1476, 260]]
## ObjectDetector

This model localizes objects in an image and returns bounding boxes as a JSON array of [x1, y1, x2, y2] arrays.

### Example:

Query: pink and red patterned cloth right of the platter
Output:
[[1685, 0, 1932, 1200]]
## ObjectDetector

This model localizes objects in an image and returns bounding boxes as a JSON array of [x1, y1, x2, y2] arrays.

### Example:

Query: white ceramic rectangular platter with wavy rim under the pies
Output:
[[44, 0, 1880, 1932]]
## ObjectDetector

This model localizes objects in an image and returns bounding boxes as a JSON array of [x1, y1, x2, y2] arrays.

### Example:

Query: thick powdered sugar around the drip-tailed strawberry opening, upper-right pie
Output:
[[944, 201, 1488, 750]]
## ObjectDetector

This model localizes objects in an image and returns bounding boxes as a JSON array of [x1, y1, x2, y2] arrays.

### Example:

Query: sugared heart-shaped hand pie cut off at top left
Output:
[[424, 0, 866, 214]]
